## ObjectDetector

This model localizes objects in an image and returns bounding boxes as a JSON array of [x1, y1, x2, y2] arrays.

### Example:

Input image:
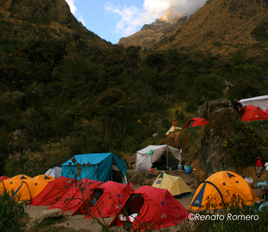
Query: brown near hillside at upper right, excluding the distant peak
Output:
[[155, 0, 268, 57]]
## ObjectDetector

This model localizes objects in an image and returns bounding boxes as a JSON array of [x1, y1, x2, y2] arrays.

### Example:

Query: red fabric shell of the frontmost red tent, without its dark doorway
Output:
[[109, 186, 189, 231]]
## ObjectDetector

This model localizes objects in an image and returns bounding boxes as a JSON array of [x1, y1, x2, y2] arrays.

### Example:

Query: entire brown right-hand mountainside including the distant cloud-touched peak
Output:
[[119, 0, 268, 57]]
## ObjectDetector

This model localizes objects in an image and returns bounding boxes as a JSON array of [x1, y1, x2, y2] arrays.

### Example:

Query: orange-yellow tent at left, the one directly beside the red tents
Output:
[[14, 175, 55, 201]]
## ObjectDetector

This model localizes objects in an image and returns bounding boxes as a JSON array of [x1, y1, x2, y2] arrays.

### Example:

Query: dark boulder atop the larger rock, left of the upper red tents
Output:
[[197, 98, 231, 120]]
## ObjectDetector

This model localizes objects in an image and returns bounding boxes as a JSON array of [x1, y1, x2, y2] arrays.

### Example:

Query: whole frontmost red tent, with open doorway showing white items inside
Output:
[[109, 185, 189, 231]]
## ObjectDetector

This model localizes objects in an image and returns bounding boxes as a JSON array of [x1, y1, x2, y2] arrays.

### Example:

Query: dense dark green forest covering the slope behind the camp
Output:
[[0, 0, 268, 176]]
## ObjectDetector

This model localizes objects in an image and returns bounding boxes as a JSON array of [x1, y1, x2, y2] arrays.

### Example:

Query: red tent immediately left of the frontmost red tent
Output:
[[85, 181, 135, 218]]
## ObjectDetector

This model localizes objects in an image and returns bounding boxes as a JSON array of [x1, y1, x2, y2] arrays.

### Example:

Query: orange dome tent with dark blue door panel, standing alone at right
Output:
[[189, 171, 259, 210]]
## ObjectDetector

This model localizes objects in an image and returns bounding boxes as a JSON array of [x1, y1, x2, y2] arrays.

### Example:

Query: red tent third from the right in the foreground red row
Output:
[[48, 178, 103, 212]]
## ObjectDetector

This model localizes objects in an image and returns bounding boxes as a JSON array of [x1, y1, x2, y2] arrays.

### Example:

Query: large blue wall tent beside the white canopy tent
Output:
[[61, 153, 127, 182]]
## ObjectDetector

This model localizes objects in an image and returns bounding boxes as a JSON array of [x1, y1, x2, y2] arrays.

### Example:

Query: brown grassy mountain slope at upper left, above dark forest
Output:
[[0, 0, 109, 47]]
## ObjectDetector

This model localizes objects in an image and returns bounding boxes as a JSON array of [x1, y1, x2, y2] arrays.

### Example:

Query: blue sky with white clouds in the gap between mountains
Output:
[[66, 0, 206, 44]]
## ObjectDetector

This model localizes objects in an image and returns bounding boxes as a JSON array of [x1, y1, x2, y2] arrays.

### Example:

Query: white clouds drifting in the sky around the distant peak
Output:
[[105, 0, 206, 37]]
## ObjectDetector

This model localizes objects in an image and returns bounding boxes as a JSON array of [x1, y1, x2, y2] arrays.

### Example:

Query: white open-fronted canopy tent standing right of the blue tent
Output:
[[135, 144, 182, 172]]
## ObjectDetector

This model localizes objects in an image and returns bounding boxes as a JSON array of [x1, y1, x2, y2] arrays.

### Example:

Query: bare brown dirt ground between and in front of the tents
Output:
[[25, 170, 261, 232]]
